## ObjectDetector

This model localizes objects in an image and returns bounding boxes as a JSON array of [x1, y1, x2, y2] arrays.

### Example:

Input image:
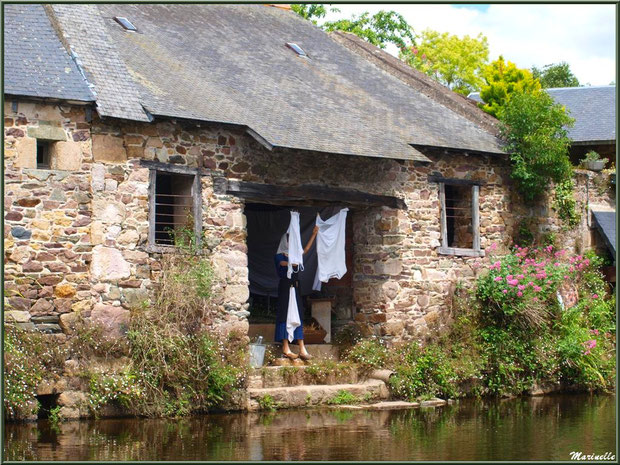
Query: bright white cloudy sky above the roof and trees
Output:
[[324, 3, 616, 86]]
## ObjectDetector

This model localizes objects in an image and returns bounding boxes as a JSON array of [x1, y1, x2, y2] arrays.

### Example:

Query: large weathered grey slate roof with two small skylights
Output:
[[41, 4, 503, 161]]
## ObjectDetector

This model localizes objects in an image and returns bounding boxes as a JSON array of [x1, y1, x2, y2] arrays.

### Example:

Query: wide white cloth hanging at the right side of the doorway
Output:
[[312, 208, 349, 291]]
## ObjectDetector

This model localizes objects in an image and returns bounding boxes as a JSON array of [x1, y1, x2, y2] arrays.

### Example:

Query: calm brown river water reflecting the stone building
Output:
[[5, 395, 616, 461]]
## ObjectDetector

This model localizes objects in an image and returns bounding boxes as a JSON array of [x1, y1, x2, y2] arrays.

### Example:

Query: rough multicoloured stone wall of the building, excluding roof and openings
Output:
[[5, 102, 611, 348]]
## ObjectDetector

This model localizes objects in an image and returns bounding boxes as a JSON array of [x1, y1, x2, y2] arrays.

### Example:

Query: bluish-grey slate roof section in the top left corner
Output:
[[3, 4, 95, 102]]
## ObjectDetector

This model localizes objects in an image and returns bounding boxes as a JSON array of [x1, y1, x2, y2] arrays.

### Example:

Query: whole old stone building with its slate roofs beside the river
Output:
[[4, 4, 612, 348]]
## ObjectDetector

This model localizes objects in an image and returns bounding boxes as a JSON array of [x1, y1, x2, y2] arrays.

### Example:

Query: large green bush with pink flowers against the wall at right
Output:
[[474, 246, 616, 393]]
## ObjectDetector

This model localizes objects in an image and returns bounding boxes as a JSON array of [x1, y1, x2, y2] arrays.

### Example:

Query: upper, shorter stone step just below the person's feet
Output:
[[248, 362, 359, 388]]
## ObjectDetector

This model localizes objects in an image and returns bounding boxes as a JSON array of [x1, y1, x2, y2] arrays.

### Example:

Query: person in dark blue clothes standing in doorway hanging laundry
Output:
[[274, 226, 319, 360]]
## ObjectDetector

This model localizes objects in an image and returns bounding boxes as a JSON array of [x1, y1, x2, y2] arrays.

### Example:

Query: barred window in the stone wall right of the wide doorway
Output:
[[438, 179, 484, 257]]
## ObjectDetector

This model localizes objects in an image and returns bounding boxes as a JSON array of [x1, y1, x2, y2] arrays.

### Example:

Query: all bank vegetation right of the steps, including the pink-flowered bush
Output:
[[346, 246, 616, 400]]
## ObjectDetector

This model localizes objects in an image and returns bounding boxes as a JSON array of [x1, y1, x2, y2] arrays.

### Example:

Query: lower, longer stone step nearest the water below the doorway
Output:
[[247, 379, 389, 411]]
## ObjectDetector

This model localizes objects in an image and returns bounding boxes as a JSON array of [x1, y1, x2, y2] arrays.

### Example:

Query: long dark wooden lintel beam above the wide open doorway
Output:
[[214, 179, 407, 209]]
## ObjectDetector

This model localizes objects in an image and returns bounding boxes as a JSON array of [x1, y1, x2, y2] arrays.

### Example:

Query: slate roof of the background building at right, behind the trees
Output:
[[468, 86, 616, 143]]
